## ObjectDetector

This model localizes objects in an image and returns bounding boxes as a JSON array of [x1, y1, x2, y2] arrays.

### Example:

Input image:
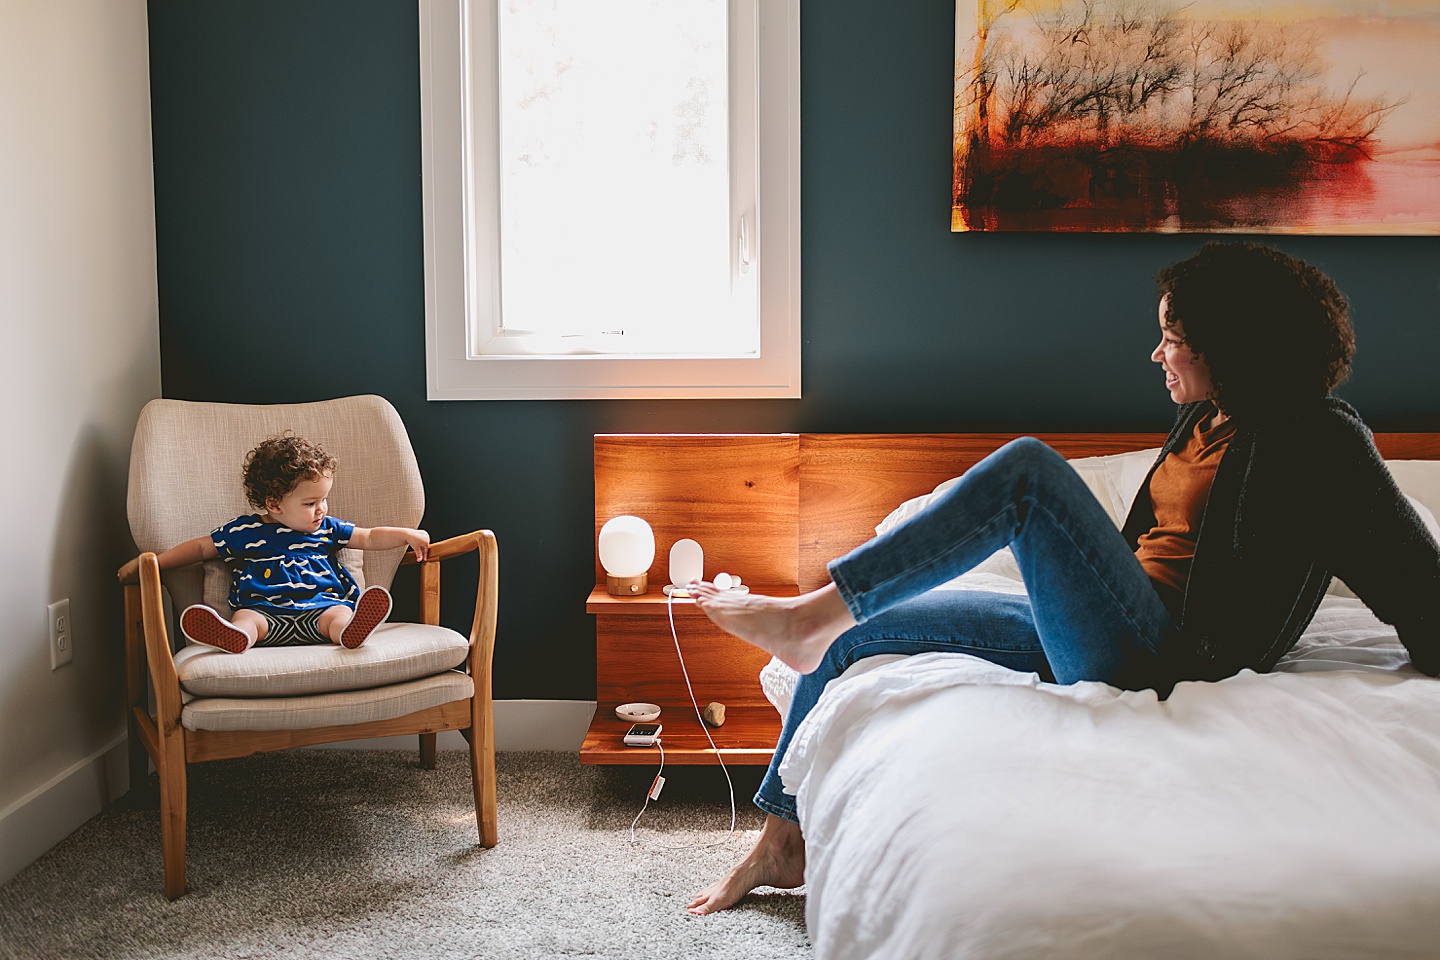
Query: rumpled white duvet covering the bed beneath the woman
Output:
[[772, 597, 1440, 960]]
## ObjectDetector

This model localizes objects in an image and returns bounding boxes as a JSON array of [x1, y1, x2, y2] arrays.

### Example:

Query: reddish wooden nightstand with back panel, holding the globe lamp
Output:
[[580, 435, 799, 764]]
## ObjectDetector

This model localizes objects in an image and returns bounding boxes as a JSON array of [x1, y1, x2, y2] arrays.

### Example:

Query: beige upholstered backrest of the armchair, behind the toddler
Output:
[[127, 396, 425, 612]]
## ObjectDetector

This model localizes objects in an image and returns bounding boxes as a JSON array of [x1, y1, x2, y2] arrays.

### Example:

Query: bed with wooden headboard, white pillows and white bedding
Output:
[[595, 433, 1440, 960]]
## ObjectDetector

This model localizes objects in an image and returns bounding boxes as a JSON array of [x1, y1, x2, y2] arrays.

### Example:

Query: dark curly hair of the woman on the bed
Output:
[[1158, 243, 1355, 416]]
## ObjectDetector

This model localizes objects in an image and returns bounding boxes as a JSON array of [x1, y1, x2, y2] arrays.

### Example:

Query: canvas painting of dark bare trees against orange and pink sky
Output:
[[950, 0, 1440, 235]]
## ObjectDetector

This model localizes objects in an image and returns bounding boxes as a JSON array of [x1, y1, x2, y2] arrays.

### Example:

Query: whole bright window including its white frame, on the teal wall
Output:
[[420, 0, 799, 400]]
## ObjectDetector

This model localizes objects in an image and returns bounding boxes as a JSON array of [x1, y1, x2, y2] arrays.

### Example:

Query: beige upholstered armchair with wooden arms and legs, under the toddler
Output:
[[115, 396, 498, 900]]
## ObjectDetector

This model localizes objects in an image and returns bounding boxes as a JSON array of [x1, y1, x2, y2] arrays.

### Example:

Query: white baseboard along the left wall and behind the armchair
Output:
[[0, 699, 595, 884]]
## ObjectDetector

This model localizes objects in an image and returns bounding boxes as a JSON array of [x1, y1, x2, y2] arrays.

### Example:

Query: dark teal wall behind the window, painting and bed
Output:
[[150, 0, 1440, 699]]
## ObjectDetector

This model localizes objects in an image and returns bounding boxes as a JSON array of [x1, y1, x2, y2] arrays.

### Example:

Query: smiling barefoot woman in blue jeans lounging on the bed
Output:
[[688, 243, 1440, 914]]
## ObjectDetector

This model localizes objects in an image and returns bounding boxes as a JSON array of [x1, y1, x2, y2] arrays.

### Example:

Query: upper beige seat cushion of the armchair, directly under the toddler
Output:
[[176, 623, 469, 697]]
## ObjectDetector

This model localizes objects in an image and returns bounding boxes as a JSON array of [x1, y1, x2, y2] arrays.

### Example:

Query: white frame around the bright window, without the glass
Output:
[[419, 0, 801, 400]]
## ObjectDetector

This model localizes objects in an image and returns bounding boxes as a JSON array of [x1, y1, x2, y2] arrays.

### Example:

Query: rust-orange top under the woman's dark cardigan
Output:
[[1135, 417, 1236, 610]]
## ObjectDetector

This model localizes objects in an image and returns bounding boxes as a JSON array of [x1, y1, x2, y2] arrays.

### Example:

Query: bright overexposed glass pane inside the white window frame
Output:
[[481, 0, 759, 356]]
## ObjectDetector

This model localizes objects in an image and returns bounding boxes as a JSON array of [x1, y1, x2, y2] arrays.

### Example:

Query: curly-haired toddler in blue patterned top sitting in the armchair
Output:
[[120, 432, 431, 653]]
